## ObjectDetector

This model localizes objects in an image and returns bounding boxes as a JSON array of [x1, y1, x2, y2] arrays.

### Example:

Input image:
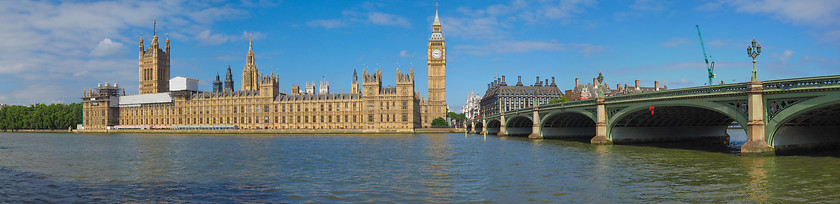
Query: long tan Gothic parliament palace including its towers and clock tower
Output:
[[82, 10, 447, 132]]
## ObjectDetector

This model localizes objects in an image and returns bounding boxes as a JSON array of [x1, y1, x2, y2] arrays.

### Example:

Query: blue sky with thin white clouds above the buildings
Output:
[[0, 0, 840, 112]]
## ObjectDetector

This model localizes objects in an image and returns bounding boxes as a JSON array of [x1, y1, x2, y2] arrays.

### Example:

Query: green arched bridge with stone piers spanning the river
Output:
[[467, 75, 840, 154]]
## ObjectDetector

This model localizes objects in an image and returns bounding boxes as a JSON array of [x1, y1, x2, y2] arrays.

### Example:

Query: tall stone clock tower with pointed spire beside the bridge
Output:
[[422, 8, 446, 127]]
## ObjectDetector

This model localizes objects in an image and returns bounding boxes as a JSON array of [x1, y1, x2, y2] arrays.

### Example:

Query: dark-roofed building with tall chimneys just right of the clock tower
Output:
[[479, 76, 563, 115]]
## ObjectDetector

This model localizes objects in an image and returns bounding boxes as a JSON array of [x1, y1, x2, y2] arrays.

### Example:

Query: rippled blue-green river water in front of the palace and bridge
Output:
[[0, 131, 840, 203]]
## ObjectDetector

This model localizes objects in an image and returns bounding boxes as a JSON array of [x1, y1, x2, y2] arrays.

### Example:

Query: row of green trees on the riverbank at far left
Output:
[[0, 103, 82, 130]]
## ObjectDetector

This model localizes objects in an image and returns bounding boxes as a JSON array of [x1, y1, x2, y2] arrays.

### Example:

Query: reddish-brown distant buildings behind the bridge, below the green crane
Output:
[[565, 78, 668, 101]]
